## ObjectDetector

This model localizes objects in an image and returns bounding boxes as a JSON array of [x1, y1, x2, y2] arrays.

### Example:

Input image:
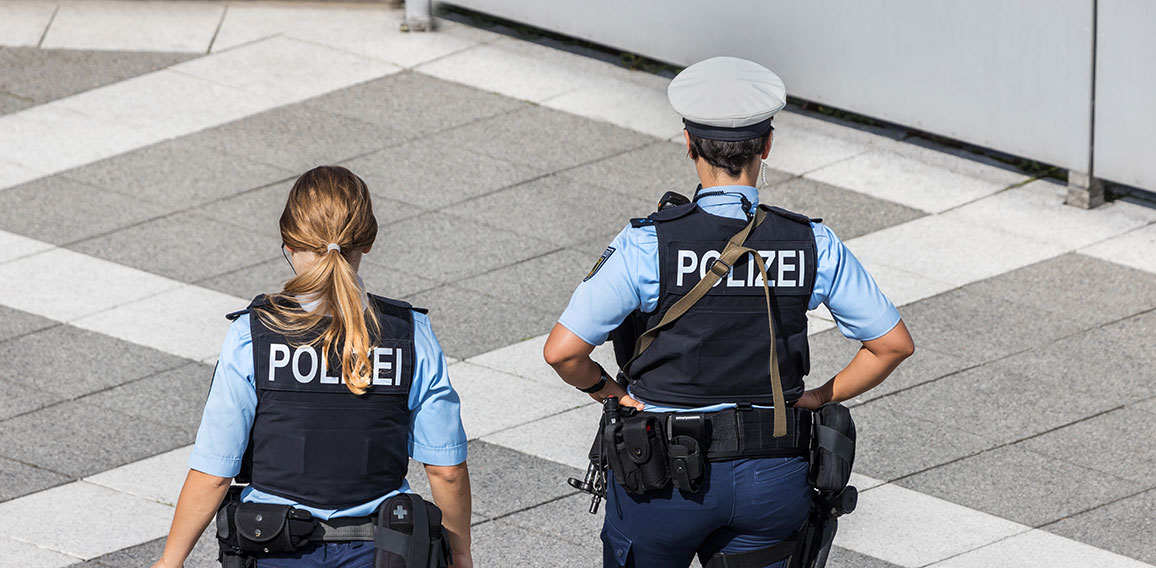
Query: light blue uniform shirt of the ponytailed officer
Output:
[[188, 305, 466, 518]]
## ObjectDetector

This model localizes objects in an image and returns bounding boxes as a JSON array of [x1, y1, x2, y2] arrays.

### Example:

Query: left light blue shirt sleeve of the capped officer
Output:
[[558, 226, 659, 345]]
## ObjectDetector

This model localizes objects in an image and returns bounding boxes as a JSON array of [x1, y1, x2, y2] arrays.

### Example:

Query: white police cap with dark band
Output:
[[666, 57, 787, 140]]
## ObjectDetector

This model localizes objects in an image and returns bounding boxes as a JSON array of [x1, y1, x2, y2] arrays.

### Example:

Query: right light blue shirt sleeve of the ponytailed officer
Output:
[[409, 312, 466, 465]]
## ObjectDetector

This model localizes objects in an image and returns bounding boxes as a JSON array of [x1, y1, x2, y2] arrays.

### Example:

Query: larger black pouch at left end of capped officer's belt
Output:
[[602, 414, 670, 495]]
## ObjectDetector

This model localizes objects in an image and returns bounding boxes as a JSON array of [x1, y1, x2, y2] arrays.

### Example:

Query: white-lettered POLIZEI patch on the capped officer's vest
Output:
[[666, 241, 815, 296]]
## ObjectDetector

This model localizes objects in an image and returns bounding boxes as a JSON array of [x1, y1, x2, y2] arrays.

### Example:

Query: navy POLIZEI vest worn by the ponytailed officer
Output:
[[227, 295, 424, 509]]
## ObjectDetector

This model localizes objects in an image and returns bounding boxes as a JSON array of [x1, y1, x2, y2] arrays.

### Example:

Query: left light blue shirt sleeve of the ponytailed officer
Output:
[[188, 313, 257, 478]]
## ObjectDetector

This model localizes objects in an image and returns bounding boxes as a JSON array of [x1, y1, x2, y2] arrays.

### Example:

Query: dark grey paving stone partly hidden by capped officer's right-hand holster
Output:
[[853, 399, 996, 481]]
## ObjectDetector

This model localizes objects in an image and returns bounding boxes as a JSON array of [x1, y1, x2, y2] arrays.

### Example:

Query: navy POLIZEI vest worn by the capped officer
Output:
[[627, 204, 816, 407]]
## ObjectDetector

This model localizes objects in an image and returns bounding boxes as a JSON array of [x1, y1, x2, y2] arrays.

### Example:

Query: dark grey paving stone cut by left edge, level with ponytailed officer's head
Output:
[[0, 176, 171, 244]]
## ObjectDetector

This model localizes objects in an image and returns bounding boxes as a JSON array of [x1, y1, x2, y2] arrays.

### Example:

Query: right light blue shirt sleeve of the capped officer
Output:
[[808, 223, 899, 341]]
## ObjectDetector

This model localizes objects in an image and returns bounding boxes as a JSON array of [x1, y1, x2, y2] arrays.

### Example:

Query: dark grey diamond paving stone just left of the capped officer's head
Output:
[[432, 106, 654, 174]]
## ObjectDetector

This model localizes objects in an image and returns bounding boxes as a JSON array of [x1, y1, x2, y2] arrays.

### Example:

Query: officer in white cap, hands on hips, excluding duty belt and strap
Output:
[[544, 57, 914, 567]]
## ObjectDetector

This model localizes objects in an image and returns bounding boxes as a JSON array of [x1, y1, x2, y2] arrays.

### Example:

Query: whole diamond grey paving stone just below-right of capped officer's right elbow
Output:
[[865, 366, 1113, 443]]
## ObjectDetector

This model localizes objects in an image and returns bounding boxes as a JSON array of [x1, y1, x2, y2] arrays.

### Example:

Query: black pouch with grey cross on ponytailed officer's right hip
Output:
[[373, 493, 451, 568]]
